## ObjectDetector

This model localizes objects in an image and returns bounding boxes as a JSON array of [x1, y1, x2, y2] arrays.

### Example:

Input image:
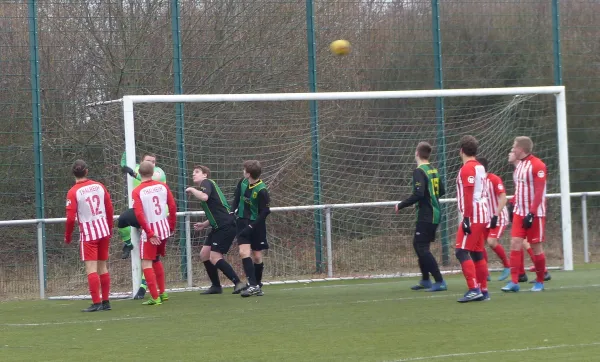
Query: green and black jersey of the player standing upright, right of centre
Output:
[[399, 163, 446, 224]]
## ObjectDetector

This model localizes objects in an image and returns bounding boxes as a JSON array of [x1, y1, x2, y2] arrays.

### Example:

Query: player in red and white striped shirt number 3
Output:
[[132, 161, 177, 305]]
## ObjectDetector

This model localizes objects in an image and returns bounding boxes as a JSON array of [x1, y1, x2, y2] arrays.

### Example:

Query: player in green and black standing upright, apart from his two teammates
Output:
[[395, 142, 447, 292]]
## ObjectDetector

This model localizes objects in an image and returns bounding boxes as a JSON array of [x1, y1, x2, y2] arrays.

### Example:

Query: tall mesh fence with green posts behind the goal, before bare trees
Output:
[[0, 0, 600, 295]]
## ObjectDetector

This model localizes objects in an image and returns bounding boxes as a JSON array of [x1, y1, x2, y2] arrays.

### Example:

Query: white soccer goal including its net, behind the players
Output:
[[89, 86, 573, 296]]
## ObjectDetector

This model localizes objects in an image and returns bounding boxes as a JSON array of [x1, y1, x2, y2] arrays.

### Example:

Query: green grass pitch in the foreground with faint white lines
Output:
[[0, 266, 600, 362]]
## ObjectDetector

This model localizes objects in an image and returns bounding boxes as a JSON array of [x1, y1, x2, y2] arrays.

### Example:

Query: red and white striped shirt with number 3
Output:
[[132, 180, 177, 241]]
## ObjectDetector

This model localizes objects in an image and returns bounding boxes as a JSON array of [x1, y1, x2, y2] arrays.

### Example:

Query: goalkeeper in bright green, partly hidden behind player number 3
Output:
[[118, 152, 167, 299]]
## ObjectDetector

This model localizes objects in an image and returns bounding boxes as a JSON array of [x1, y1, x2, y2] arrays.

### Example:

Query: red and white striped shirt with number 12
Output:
[[65, 179, 114, 242]]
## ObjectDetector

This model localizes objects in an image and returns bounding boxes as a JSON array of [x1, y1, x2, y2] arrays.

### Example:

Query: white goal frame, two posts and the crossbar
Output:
[[122, 86, 573, 294]]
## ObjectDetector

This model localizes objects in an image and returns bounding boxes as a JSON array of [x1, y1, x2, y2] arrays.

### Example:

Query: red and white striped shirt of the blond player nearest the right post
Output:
[[513, 155, 548, 217]]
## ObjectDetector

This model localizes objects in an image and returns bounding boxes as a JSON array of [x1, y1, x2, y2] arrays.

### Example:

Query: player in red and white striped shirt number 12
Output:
[[65, 160, 114, 312]]
